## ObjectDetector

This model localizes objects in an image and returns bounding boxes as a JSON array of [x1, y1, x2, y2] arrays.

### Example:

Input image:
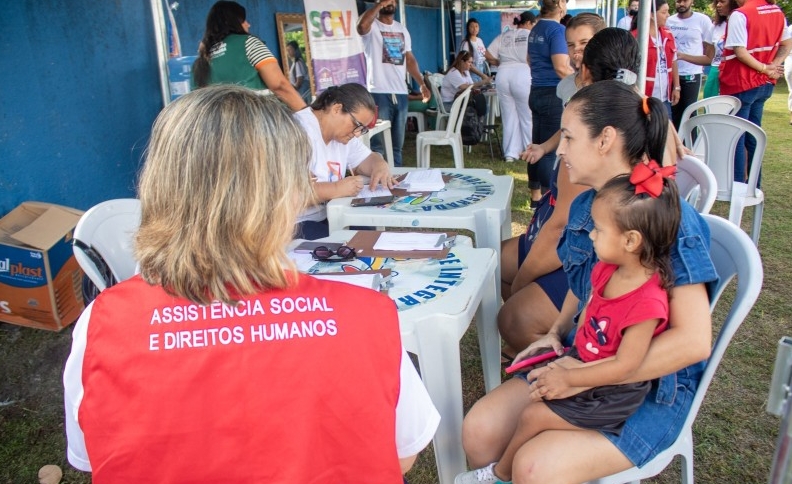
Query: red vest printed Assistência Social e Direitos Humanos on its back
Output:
[[79, 276, 402, 484]]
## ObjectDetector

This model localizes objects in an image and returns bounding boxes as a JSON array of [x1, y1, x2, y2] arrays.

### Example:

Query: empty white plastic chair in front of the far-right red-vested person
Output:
[[680, 114, 767, 245]]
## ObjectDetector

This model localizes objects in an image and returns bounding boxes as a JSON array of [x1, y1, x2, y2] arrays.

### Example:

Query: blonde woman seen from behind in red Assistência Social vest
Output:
[[64, 85, 439, 484]]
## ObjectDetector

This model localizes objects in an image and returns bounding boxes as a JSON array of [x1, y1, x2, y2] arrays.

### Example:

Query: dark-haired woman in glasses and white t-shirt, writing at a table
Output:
[[294, 84, 394, 240]]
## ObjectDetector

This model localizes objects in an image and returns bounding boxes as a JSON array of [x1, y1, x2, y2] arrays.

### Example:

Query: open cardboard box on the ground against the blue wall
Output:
[[0, 202, 85, 331]]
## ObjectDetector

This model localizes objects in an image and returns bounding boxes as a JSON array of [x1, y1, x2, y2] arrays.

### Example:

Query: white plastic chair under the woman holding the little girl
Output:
[[589, 215, 763, 484]]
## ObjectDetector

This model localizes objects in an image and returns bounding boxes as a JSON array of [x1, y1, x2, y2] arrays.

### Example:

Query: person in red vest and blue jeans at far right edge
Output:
[[718, 0, 792, 182]]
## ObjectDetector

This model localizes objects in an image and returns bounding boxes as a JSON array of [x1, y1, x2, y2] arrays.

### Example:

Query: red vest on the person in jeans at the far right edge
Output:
[[718, 0, 784, 94]]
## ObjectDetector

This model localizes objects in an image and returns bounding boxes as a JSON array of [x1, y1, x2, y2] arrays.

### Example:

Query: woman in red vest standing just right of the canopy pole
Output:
[[632, 0, 681, 116]]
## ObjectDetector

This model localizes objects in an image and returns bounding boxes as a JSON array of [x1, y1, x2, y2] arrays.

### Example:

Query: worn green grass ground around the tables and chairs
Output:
[[0, 83, 792, 484]]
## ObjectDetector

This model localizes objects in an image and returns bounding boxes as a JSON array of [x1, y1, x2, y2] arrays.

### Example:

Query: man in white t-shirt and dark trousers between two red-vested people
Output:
[[666, 0, 715, 129]]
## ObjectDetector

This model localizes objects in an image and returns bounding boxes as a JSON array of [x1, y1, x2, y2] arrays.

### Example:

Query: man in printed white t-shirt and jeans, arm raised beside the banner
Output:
[[357, 0, 432, 166]]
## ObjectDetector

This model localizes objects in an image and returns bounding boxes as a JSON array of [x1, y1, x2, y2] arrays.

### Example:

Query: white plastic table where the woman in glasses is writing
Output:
[[327, 168, 514, 298]]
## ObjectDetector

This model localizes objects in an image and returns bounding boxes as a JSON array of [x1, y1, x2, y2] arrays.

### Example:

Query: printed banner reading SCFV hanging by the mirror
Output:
[[304, 0, 366, 94]]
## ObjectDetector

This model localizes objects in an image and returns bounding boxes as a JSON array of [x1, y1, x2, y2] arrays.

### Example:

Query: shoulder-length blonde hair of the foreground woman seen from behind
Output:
[[135, 85, 313, 304]]
